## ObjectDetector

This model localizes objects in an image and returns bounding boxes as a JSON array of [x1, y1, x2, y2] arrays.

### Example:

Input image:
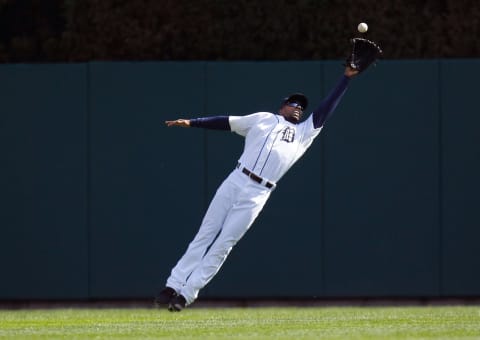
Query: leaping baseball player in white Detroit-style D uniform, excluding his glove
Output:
[[155, 66, 358, 311]]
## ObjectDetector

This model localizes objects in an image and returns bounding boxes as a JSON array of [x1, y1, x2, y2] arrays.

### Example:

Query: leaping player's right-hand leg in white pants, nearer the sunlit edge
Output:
[[180, 189, 270, 305]]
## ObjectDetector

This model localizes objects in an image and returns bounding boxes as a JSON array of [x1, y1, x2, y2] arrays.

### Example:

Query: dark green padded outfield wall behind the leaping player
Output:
[[0, 59, 480, 300]]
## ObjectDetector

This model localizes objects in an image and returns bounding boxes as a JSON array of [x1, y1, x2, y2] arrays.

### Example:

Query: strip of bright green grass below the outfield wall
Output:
[[0, 306, 480, 339]]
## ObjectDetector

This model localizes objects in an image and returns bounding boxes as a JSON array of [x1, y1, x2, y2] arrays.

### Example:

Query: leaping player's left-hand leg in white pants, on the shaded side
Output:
[[166, 180, 238, 292]]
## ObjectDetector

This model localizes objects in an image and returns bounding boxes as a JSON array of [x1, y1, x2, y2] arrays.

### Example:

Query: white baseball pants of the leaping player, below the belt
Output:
[[167, 169, 271, 305]]
